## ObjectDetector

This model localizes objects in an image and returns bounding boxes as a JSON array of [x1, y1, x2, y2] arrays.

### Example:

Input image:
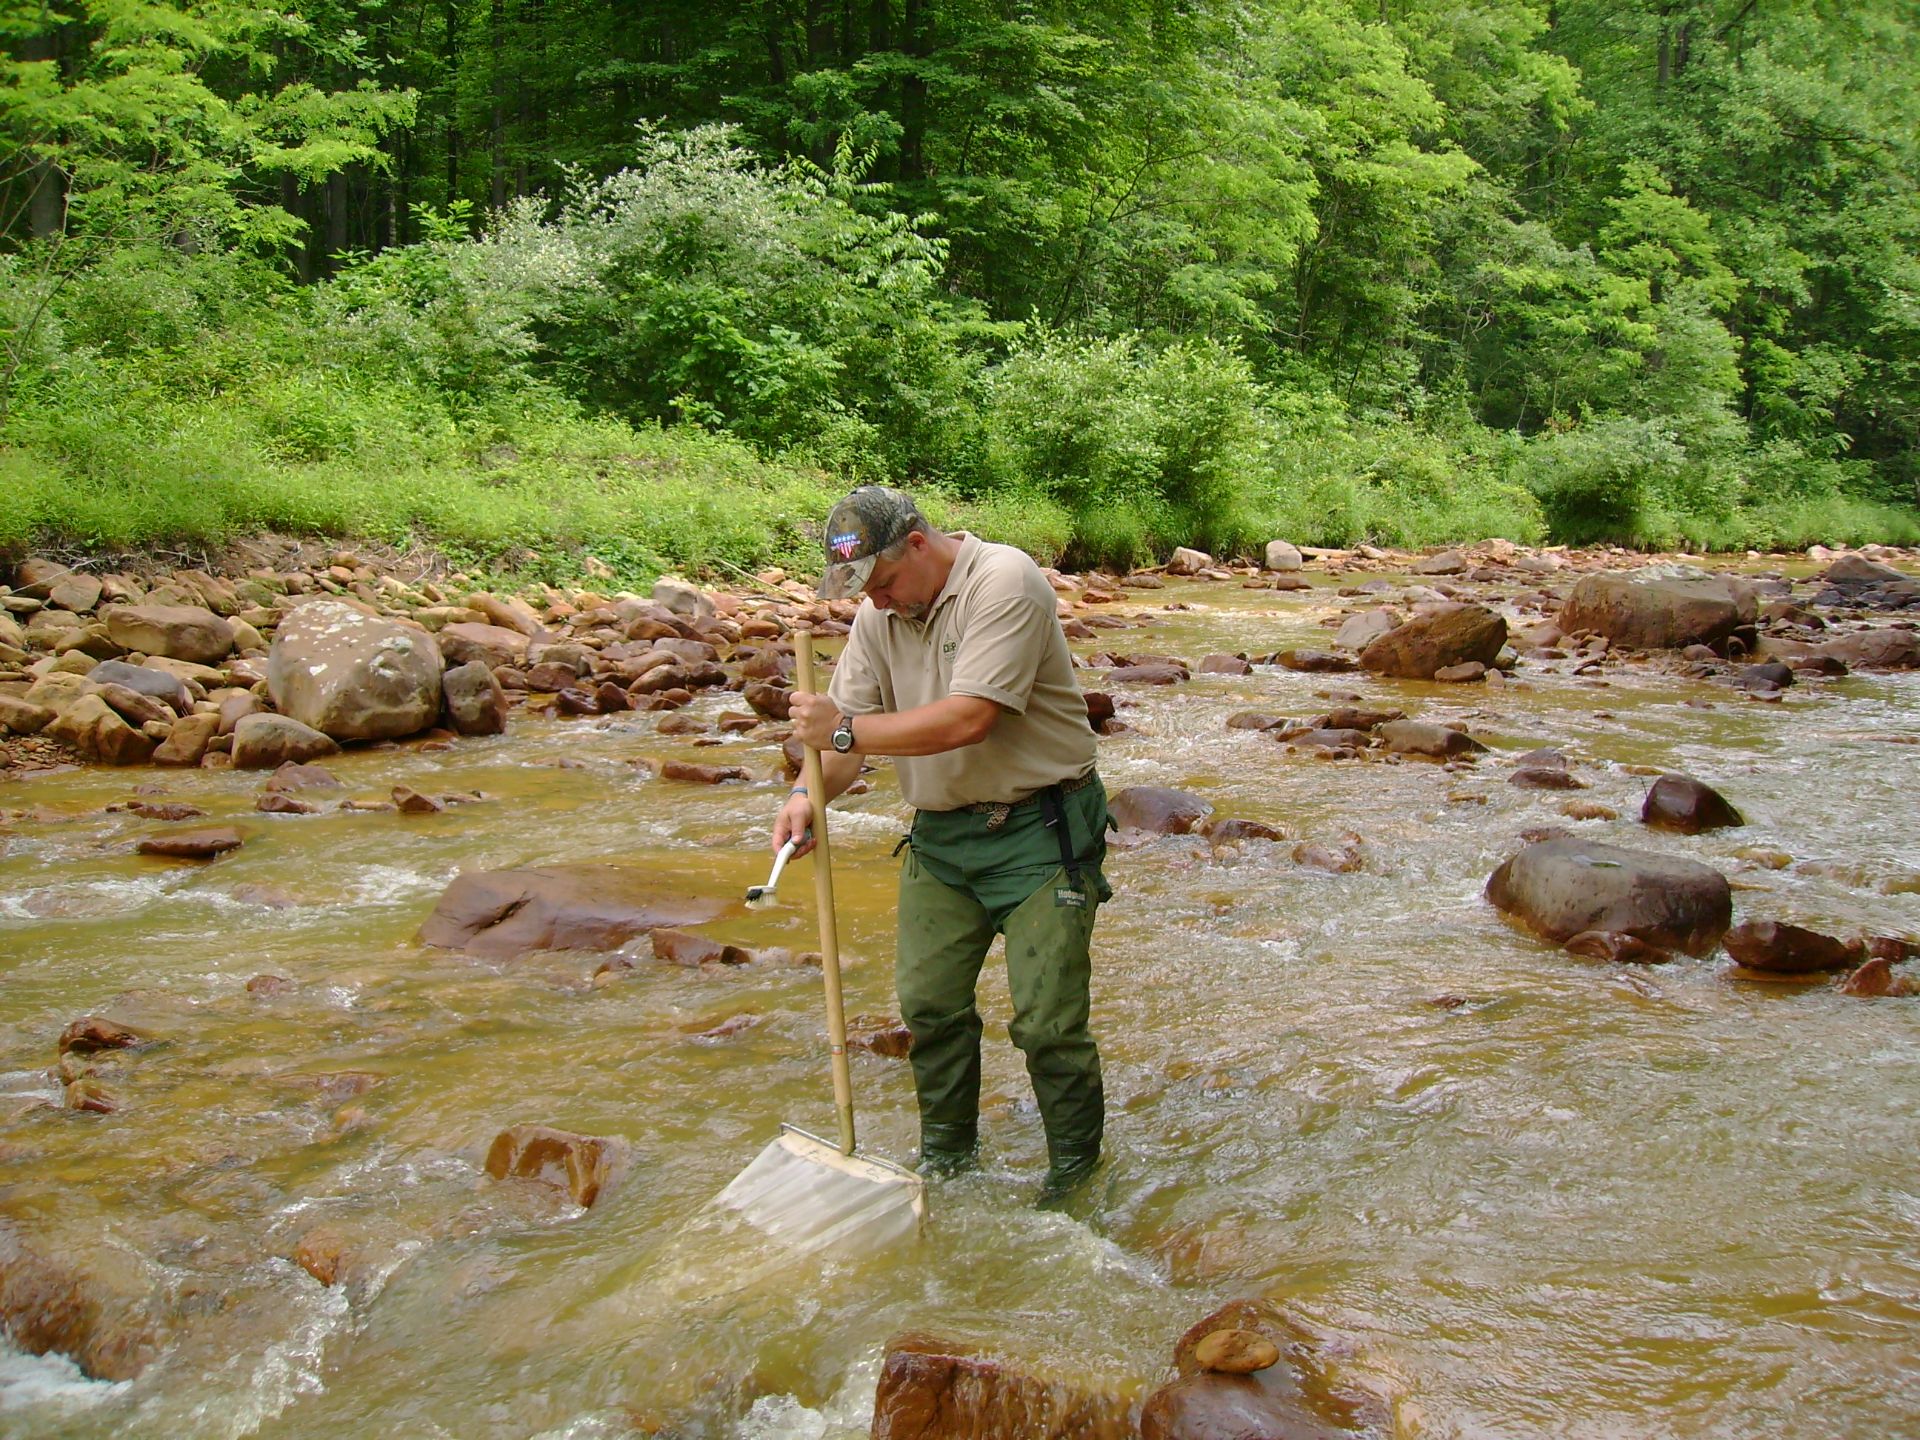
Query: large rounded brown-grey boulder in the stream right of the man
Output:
[[1486, 839, 1734, 954]]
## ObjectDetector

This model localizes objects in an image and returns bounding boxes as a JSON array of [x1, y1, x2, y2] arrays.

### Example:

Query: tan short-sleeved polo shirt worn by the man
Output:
[[828, 532, 1094, 810]]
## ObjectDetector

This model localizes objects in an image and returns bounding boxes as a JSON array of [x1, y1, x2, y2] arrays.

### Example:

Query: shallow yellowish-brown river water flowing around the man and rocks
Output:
[[0, 584, 1920, 1440]]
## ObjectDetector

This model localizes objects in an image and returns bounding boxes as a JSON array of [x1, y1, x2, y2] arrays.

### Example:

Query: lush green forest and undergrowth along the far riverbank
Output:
[[0, 0, 1920, 578]]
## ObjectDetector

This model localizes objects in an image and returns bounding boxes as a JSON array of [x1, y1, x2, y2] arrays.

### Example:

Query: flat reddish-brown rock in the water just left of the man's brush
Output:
[[419, 864, 726, 960]]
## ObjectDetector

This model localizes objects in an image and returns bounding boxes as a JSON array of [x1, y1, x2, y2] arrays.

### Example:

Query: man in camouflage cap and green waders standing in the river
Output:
[[774, 486, 1112, 1196]]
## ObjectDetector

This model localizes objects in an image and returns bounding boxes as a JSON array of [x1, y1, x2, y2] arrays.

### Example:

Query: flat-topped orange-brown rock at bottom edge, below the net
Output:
[[870, 1334, 1133, 1440]]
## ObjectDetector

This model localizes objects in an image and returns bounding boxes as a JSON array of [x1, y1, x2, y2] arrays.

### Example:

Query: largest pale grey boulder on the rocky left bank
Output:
[[267, 599, 444, 739]]
